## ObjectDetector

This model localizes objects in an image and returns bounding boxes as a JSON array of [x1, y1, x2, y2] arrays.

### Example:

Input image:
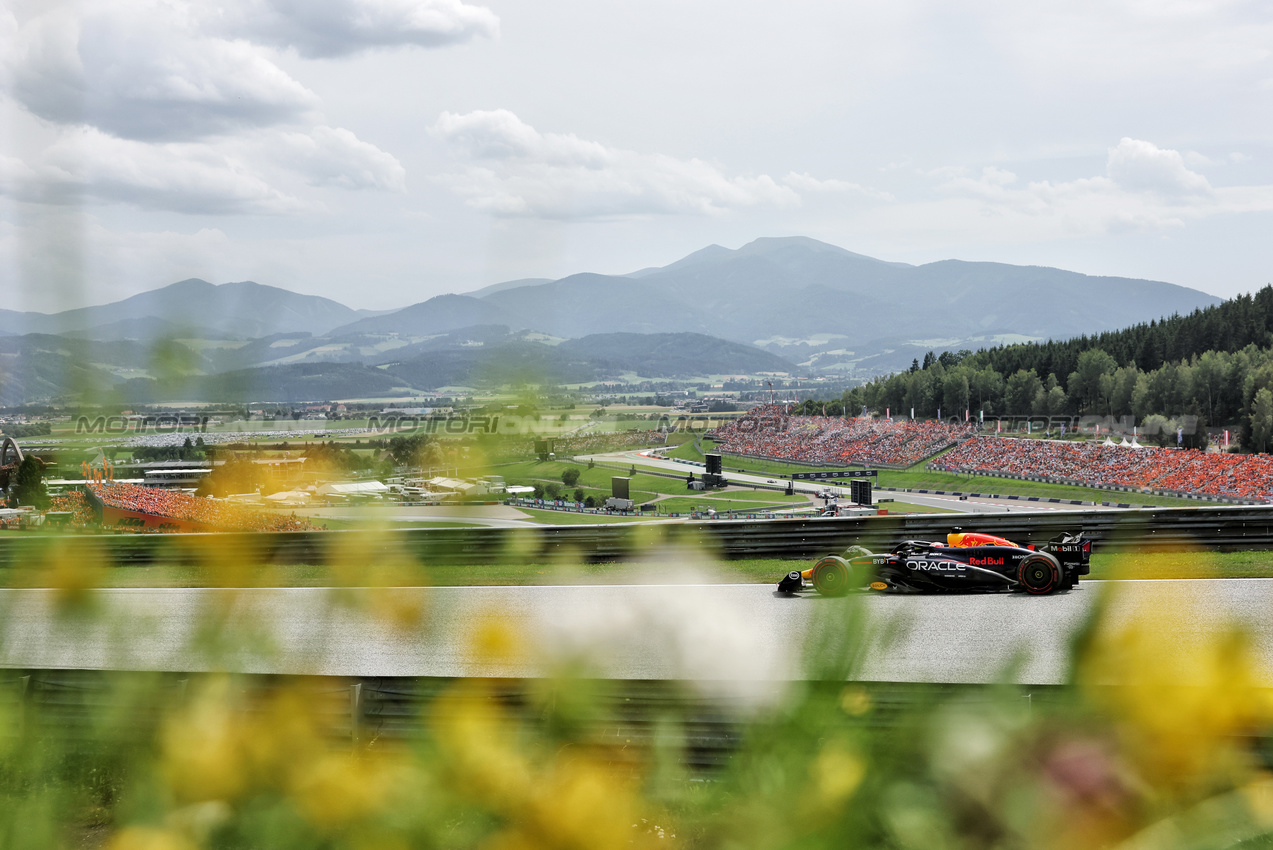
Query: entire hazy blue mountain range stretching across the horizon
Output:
[[0, 237, 1220, 403]]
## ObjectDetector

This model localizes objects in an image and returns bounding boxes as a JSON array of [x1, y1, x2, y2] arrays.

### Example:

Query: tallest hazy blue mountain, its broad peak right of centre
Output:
[[463, 237, 1220, 344]]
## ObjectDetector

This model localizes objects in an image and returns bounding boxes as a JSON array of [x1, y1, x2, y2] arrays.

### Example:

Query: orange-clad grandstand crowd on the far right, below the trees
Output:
[[931, 436, 1273, 500]]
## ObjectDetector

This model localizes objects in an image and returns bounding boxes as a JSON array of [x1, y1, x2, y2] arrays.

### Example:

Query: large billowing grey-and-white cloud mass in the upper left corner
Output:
[[0, 0, 414, 214]]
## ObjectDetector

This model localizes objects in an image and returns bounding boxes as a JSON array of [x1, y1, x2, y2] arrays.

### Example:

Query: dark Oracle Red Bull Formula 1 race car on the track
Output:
[[778, 532, 1092, 597]]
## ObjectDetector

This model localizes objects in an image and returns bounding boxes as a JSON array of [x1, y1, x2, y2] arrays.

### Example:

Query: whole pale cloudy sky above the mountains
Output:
[[0, 0, 1273, 310]]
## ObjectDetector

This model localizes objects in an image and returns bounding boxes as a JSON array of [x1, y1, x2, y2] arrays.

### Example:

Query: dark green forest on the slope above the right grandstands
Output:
[[798, 286, 1273, 452]]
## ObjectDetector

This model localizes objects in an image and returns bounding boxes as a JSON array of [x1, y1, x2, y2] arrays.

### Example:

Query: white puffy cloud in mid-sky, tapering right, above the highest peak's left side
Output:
[[433, 109, 799, 219]]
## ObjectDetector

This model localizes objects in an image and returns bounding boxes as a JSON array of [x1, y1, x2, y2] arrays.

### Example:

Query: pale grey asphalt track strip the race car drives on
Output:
[[0, 579, 1273, 687]]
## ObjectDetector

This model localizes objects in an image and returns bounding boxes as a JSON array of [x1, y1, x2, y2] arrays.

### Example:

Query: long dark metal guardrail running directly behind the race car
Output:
[[0, 506, 1273, 569]]
